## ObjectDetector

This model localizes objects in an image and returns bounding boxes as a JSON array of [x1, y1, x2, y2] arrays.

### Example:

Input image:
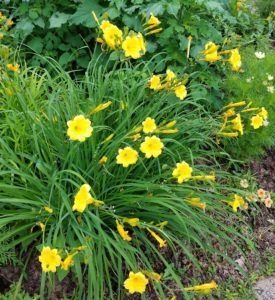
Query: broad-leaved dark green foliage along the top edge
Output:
[[0, 0, 266, 71]]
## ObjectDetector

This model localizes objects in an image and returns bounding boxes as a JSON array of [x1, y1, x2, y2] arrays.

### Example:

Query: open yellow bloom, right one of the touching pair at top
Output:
[[122, 32, 146, 59]]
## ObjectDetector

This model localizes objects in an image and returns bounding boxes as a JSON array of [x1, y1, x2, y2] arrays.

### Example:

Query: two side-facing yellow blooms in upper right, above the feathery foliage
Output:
[[201, 42, 242, 71]]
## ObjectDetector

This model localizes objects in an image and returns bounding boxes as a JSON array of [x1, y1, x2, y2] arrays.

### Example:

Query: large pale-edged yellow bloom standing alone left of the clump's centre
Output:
[[67, 115, 93, 142]]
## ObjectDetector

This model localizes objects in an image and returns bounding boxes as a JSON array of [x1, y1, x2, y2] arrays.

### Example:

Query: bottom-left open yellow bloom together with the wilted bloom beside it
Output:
[[38, 246, 86, 273]]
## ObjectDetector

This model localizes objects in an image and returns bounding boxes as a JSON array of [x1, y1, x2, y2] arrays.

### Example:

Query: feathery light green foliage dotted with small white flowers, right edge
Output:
[[223, 41, 275, 159]]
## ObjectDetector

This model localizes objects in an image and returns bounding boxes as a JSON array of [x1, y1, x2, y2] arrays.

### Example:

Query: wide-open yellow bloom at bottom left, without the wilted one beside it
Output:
[[39, 247, 61, 272]]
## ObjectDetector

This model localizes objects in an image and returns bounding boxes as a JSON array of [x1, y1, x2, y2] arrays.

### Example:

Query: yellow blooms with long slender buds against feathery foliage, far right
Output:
[[218, 101, 268, 137]]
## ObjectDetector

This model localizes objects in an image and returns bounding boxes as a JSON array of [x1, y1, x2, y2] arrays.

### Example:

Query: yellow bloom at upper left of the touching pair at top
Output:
[[100, 21, 122, 49]]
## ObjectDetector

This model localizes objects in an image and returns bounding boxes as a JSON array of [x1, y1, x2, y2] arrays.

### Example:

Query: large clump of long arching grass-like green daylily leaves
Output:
[[0, 55, 256, 299]]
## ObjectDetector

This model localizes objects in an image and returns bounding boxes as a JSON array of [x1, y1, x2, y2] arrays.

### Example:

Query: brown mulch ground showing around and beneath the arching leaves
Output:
[[0, 149, 275, 300]]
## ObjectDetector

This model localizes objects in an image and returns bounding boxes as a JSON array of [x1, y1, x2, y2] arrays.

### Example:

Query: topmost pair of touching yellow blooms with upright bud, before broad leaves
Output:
[[92, 12, 146, 59]]
